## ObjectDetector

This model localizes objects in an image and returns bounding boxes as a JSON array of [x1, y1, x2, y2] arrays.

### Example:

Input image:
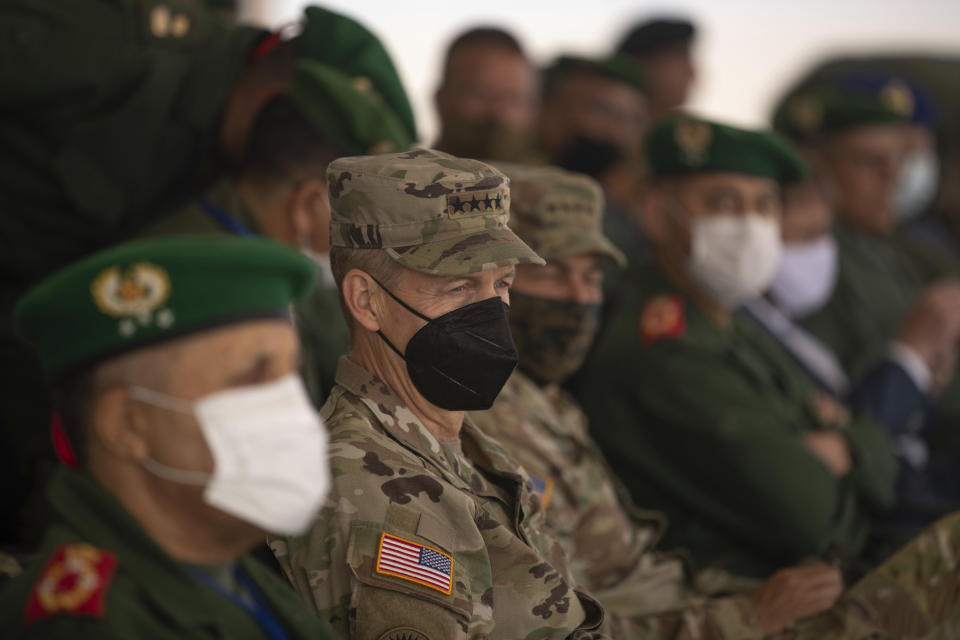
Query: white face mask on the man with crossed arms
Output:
[[688, 214, 781, 309]]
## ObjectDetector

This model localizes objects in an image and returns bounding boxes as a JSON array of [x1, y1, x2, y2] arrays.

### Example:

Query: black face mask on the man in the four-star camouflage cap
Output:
[[377, 282, 517, 411]]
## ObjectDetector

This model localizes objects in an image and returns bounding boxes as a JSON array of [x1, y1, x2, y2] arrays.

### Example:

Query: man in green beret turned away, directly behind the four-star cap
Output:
[[142, 33, 413, 407]]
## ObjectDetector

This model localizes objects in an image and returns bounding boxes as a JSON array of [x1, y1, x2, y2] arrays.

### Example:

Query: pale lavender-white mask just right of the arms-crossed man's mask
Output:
[[770, 234, 837, 318]]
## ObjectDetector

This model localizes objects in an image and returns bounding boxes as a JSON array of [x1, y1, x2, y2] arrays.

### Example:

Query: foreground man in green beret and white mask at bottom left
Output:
[[0, 236, 333, 640]]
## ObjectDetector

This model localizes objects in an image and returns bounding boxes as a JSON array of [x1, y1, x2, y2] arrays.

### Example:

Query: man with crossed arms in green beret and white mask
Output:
[[578, 116, 895, 577]]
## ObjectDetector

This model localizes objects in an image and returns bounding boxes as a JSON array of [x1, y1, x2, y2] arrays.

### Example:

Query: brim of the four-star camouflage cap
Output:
[[384, 227, 546, 276]]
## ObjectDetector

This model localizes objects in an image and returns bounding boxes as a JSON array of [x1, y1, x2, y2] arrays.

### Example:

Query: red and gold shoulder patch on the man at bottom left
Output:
[[23, 543, 117, 625]]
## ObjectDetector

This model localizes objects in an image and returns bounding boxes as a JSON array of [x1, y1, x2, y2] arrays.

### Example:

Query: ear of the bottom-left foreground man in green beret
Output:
[[90, 387, 150, 463]]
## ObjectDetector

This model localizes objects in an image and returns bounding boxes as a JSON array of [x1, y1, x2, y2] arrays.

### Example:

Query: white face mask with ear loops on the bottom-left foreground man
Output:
[[130, 374, 330, 535]]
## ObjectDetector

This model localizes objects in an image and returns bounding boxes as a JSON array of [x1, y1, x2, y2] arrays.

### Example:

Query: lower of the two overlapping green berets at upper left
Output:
[[286, 60, 414, 155]]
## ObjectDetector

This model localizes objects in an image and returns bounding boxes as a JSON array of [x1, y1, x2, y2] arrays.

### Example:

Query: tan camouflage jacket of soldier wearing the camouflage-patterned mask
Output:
[[471, 371, 763, 640]]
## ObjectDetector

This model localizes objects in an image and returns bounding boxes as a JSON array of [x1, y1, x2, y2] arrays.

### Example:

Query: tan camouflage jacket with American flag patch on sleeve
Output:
[[271, 358, 605, 640]]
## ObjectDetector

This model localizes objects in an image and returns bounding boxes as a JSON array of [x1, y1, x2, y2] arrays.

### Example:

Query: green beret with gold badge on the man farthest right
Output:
[[773, 83, 913, 142]]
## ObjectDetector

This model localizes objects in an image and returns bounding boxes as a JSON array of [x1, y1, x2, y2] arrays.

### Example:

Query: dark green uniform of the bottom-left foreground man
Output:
[[0, 468, 334, 640]]
